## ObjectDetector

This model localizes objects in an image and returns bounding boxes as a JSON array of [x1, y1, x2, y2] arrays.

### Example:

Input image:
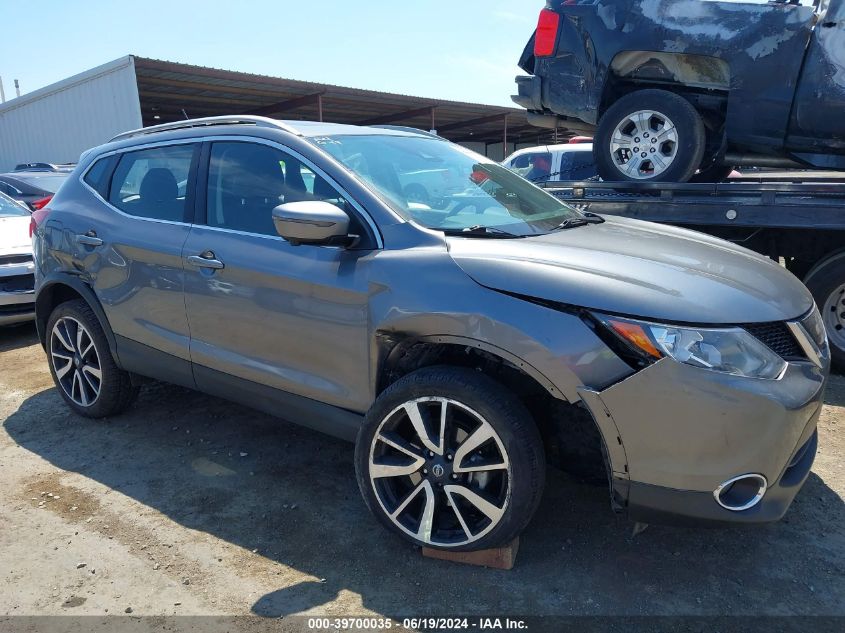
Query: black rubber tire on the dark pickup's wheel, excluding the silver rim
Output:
[[593, 90, 706, 182]]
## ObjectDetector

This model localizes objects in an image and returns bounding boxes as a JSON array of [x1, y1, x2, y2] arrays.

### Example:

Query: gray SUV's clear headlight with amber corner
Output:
[[594, 314, 786, 379]]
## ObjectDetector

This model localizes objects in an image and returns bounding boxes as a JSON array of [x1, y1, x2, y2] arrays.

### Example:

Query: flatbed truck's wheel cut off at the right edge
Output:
[[804, 251, 845, 372]]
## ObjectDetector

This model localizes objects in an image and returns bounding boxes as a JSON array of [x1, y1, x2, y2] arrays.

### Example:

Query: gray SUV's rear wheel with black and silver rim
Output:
[[46, 299, 138, 418]]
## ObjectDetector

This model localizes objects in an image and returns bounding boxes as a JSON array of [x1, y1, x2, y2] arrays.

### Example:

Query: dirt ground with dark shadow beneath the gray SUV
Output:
[[0, 326, 845, 617]]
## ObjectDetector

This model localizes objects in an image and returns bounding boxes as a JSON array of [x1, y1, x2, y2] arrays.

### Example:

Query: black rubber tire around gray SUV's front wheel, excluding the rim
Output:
[[355, 367, 545, 551]]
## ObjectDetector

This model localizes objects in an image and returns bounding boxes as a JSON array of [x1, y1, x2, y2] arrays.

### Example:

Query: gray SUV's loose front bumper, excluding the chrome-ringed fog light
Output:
[[579, 359, 828, 525]]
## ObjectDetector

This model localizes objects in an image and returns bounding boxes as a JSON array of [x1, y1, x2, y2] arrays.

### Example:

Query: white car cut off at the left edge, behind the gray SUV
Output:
[[0, 193, 35, 325]]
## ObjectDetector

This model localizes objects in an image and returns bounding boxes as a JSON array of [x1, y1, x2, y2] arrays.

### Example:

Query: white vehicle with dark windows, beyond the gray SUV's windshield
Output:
[[502, 143, 598, 183]]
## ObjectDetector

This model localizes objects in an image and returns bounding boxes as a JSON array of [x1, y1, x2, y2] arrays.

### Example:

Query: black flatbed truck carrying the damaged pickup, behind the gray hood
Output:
[[542, 171, 845, 371]]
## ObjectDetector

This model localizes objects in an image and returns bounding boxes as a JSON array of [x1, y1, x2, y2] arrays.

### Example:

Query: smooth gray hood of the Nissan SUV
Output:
[[447, 217, 813, 325]]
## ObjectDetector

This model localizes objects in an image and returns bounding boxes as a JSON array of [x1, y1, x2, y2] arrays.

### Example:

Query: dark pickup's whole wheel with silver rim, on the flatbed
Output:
[[593, 90, 707, 182]]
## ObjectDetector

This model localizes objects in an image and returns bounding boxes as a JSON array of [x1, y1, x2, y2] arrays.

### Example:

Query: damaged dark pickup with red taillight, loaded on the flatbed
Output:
[[514, 0, 845, 182]]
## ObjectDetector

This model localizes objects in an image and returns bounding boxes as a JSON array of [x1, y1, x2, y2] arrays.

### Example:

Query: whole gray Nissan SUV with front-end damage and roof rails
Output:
[[33, 117, 829, 550]]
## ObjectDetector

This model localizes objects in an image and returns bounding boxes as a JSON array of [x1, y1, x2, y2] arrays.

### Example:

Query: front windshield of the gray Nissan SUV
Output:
[[314, 135, 581, 236]]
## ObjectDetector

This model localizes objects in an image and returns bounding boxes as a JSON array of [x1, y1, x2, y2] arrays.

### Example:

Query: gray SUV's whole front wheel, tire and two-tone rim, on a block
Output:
[[355, 366, 546, 551]]
